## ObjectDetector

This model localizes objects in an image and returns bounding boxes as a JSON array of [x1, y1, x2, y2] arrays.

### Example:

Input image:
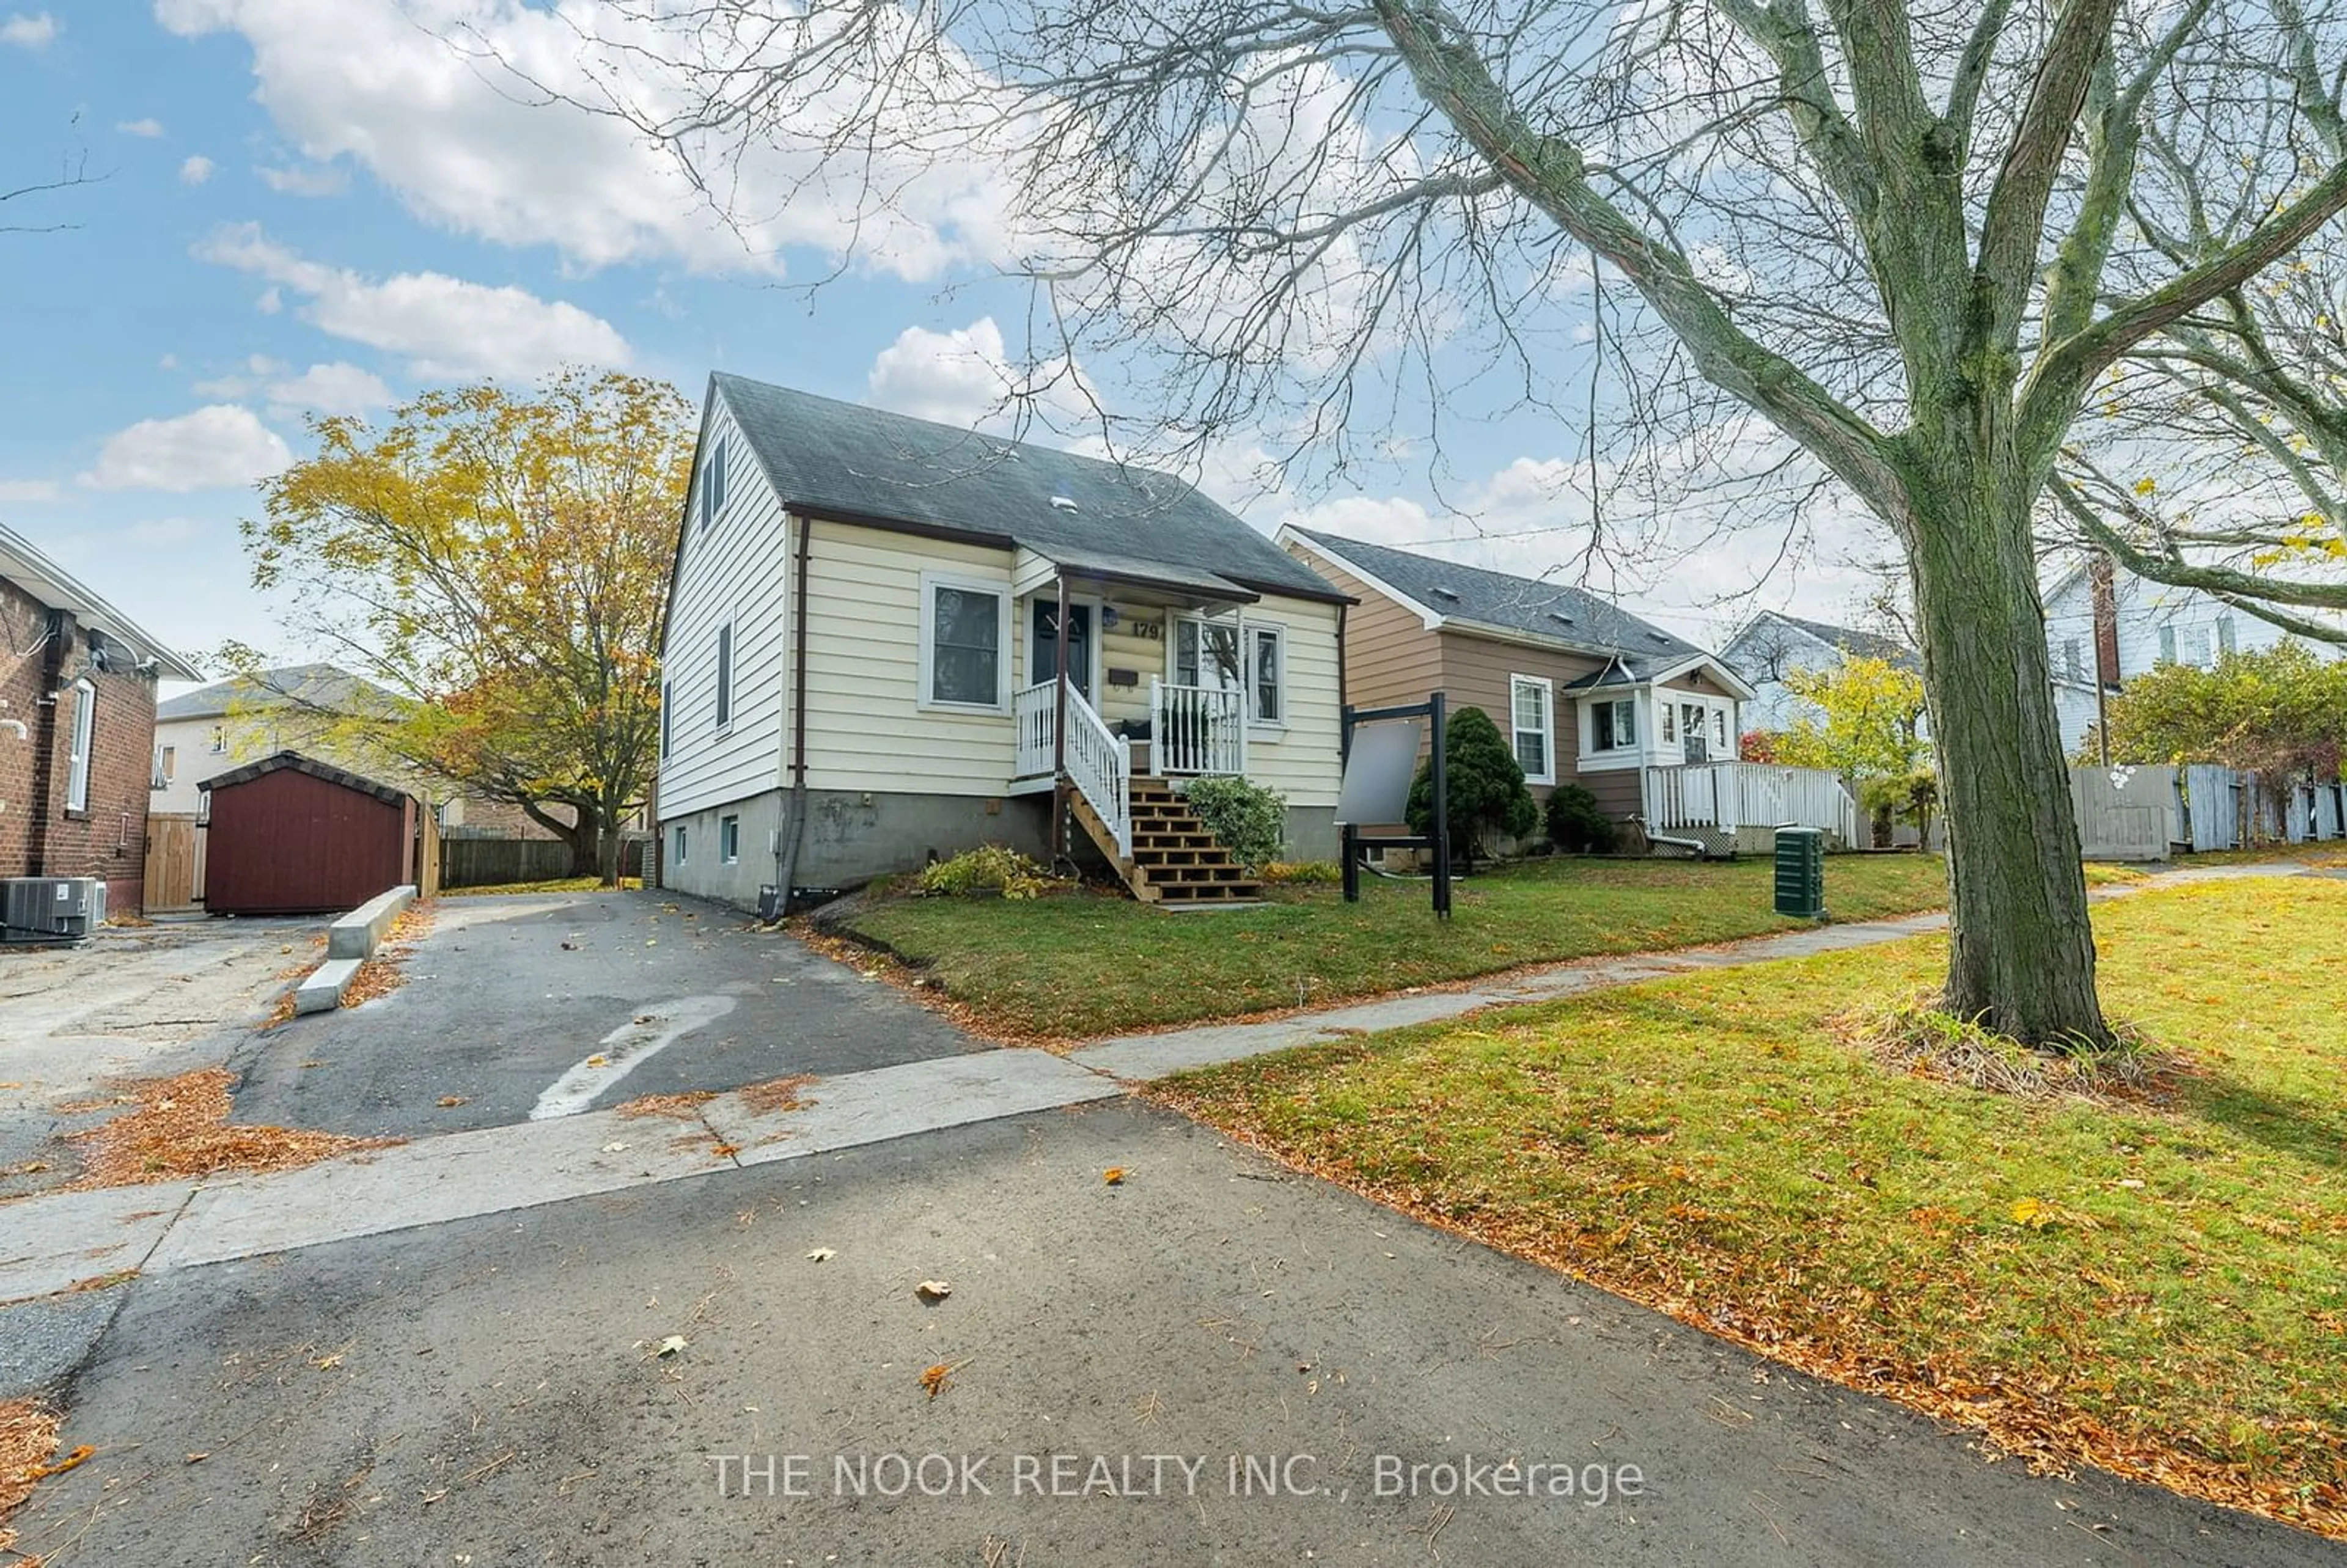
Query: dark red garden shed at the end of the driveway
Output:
[[204, 751, 418, 915]]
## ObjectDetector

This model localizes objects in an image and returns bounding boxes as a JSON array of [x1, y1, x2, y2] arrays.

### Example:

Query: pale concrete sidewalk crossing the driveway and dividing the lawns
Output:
[[0, 864, 2305, 1303]]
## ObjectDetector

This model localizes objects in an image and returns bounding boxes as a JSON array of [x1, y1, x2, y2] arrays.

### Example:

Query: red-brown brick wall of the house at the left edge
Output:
[[0, 582, 155, 913]]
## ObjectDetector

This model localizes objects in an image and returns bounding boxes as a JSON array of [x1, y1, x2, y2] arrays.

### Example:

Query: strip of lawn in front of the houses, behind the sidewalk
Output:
[[850, 854, 1945, 1040]]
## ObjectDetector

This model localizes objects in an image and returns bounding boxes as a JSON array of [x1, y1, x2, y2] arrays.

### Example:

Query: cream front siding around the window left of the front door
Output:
[[807, 519, 1026, 796]]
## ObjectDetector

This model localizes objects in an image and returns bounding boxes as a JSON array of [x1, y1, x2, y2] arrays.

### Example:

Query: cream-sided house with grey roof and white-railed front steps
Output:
[[655, 376, 1347, 904]]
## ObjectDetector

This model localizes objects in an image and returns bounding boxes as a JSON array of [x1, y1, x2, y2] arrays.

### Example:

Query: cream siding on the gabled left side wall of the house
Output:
[[659, 397, 793, 819]]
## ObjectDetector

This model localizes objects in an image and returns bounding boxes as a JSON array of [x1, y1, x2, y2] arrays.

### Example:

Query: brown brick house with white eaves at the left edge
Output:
[[0, 528, 202, 913]]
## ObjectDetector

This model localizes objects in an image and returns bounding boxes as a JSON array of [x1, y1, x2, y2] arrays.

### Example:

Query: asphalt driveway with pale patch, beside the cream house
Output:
[[237, 892, 974, 1136]]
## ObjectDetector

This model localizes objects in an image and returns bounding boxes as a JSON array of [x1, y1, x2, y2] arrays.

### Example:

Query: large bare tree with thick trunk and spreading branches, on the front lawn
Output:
[[499, 0, 2347, 1047]]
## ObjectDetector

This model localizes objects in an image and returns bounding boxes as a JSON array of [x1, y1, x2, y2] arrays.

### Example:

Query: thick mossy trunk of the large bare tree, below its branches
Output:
[[1908, 453, 2110, 1049]]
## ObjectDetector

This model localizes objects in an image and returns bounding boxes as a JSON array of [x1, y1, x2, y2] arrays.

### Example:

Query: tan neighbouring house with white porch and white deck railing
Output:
[[1279, 526, 1856, 854]]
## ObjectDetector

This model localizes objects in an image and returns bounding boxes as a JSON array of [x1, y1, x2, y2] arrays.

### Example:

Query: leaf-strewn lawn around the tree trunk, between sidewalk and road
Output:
[[1162, 880, 2347, 1537]]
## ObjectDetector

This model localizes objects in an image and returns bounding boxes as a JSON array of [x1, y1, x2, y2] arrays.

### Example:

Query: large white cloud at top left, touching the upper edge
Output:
[[155, 0, 1016, 277]]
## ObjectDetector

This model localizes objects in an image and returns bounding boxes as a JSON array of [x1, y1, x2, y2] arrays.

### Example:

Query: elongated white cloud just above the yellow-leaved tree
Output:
[[195, 223, 634, 378]]
